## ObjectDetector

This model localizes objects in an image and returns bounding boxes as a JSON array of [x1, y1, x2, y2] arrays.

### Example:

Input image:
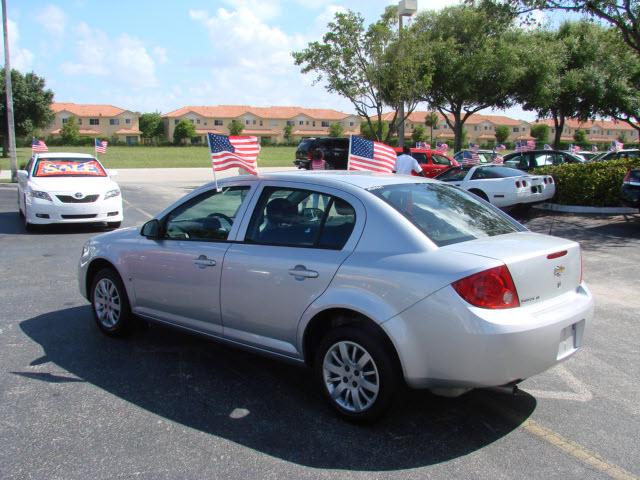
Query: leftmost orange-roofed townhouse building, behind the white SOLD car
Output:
[[44, 103, 142, 145]]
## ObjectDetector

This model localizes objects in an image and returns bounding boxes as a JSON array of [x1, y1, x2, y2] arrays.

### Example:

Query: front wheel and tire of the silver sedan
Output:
[[91, 268, 134, 337]]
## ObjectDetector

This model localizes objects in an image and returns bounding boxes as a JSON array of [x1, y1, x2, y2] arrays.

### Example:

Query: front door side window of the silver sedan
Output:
[[165, 187, 249, 241]]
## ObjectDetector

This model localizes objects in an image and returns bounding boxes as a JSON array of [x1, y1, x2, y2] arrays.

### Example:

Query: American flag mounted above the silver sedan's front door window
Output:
[[207, 133, 260, 175]]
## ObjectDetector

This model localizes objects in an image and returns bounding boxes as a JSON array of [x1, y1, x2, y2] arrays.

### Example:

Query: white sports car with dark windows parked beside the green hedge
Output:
[[435, 165, 556, 208]]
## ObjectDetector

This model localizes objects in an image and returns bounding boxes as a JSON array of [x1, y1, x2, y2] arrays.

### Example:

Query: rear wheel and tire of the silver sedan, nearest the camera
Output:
[[314, 325, 401, 423]]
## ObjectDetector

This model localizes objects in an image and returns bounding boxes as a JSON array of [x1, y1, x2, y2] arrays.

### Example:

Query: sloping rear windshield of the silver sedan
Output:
[[369, 183, 525, 247]]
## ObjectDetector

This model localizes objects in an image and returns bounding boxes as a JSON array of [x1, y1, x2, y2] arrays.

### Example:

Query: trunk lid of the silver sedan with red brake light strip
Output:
[[443, 232, 582, 306]]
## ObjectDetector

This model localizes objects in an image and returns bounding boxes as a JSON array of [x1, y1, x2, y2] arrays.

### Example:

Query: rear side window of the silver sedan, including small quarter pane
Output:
[[245, 187, 355, 249]]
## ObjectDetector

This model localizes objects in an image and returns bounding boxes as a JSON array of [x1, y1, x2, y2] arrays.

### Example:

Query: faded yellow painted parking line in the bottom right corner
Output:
[[521, 419, 639, 480]]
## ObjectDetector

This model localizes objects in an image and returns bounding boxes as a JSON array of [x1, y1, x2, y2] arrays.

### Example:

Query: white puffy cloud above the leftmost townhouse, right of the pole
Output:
[[61, 23, 159, 88]]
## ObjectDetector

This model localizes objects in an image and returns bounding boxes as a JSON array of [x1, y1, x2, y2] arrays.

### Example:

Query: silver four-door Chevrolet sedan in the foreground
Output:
[[79, 172, 593, 421]]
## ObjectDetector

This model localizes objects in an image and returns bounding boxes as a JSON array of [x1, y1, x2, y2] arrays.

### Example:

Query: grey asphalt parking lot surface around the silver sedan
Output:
[[0, 170, 640, 480]]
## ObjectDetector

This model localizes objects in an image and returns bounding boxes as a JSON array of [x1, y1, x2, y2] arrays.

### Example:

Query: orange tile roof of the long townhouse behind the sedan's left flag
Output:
[[164, 105, 351, 120]]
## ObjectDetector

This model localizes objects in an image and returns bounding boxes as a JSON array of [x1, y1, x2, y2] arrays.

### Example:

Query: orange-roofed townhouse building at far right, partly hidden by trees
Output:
[[535, 118, 640, 143]]
